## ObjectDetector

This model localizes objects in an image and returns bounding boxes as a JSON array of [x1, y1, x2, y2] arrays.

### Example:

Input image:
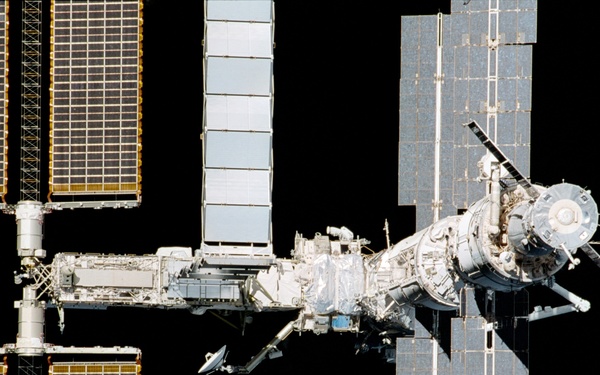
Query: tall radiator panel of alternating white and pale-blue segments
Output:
[[202, 0, 274, 255]]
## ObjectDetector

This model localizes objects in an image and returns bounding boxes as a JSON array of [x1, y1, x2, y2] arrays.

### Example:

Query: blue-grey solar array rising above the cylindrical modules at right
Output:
[[398, 0, 537, 229]]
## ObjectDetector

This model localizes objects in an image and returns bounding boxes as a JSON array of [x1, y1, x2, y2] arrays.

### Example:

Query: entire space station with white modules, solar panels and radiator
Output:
[[0, 0, 600, 375]]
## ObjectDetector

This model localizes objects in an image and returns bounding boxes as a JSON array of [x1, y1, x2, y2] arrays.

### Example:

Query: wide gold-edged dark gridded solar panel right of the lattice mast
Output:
[[50, 0, 142, 199]]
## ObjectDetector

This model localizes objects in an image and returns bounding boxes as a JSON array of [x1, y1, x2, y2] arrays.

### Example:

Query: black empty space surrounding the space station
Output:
[[0, 0, 600, 375]]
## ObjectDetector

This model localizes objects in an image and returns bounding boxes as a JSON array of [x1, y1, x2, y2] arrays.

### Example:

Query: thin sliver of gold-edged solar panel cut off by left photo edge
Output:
[[0, 1, 8, 201]]
